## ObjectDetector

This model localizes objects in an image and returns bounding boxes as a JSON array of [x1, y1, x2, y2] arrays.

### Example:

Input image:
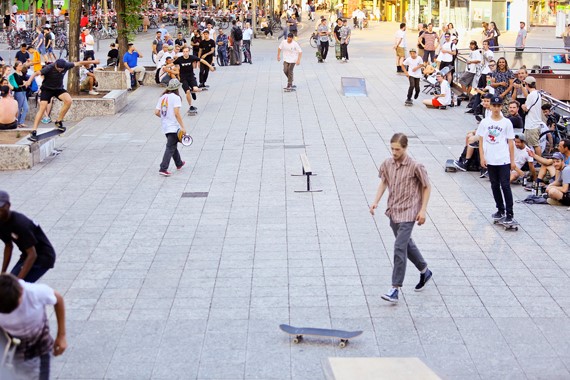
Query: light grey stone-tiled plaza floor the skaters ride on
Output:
[[0, 24, 570, 380]]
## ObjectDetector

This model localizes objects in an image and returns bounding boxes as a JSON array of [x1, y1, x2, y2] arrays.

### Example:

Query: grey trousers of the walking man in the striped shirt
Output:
[[390, 219, 427, 287]]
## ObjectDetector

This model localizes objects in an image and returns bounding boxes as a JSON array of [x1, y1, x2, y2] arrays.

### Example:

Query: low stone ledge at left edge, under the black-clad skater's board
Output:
[[0, 130, 55, 171]]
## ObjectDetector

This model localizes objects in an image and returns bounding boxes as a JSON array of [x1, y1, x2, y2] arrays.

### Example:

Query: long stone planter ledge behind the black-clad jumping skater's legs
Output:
[[26, 90, 127, 121]]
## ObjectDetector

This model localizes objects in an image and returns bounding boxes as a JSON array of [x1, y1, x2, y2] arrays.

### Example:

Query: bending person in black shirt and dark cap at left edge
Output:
[[0, 190, 55, 282]]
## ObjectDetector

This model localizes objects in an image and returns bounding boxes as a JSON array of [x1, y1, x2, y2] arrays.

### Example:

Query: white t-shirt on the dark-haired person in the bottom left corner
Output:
[[0, 280, 57, 338]]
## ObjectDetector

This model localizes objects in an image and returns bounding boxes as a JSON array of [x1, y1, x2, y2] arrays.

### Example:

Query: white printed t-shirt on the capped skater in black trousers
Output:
[[477, 115, 515, 166]]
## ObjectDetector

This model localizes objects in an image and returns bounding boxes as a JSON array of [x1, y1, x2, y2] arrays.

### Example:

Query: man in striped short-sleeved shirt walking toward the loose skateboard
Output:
[[370, 133, 432, 303]]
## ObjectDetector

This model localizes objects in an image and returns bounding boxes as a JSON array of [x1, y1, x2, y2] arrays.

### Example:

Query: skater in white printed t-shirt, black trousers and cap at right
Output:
[[477, 96, 516, 223]]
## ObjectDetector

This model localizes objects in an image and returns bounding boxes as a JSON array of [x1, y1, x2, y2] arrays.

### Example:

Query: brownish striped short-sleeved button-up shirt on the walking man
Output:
[[379, 155, 429, 223]]
